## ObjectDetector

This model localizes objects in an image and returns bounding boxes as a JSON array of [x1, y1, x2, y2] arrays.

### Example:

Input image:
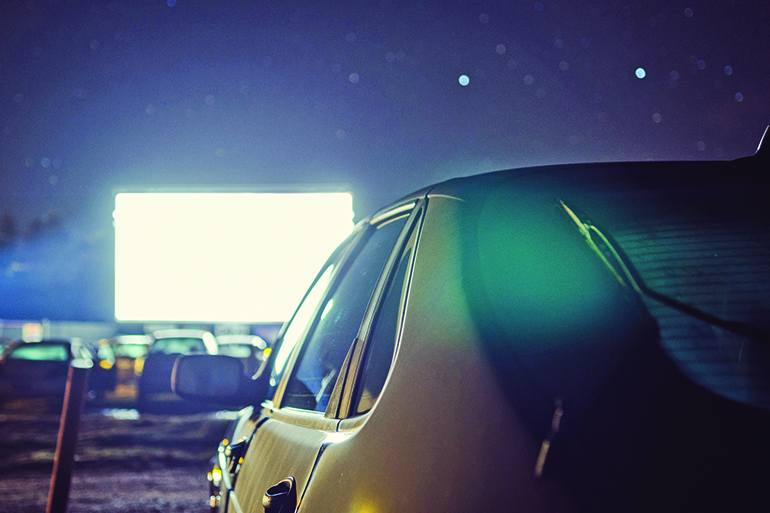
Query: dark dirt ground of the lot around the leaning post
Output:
[[0, 404, 233, 513]]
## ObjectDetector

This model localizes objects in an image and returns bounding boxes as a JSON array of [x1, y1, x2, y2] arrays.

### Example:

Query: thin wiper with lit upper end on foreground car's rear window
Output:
[[558, 200, 770, 343]]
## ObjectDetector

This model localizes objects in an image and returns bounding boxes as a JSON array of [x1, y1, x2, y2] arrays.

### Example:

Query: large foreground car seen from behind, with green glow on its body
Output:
[[174, 133, 770, 512]]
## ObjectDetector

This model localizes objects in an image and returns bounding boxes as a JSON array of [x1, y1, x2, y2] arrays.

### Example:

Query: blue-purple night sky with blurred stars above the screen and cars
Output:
[[0, 0, 770, 318]]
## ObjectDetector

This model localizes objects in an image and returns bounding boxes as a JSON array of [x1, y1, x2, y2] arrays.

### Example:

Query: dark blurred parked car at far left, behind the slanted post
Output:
[[0, 339, 104, 410]]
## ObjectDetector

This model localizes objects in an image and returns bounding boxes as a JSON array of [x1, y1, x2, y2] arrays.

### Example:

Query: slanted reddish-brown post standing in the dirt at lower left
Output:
[[46, 360, 93, 513]]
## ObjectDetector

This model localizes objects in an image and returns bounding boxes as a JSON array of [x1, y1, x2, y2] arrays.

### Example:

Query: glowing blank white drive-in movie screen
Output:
[[114, 192, 353, 323]]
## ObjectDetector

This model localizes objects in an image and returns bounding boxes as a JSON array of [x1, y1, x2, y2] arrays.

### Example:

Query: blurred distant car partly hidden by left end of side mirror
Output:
[[137, 329, 217, 413]]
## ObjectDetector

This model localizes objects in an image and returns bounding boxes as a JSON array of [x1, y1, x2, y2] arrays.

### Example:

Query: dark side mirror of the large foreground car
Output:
[[171, 354, 270, 406]]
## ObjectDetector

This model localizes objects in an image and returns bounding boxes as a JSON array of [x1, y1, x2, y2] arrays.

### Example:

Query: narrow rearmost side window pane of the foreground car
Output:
[[353, 215, 417, 414]]
